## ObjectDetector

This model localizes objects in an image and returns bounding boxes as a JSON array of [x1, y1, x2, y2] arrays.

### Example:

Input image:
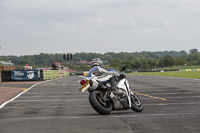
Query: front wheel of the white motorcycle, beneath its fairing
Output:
[[131, 94, 144, 112]]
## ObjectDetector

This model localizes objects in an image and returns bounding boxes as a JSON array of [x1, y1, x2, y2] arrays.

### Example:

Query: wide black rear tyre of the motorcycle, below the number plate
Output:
[[89, 90, 112, 115]]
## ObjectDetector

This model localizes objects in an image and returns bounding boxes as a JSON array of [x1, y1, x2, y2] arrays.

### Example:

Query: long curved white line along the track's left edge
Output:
[[0, 80, 52, 109]]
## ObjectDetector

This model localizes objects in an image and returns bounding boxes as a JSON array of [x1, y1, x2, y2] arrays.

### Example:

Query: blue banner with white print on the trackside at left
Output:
[[11, 70, 38, 81]]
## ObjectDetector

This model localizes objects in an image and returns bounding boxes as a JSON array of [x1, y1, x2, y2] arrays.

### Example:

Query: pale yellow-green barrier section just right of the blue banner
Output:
[[43, 70, 60, 80]]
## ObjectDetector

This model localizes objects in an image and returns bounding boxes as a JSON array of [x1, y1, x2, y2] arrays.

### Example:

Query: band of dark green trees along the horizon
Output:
[[0, 49, 200, 71]]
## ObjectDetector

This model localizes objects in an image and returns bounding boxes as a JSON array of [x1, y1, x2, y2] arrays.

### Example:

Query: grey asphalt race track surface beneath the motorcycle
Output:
[[0, 76, 200, 133]]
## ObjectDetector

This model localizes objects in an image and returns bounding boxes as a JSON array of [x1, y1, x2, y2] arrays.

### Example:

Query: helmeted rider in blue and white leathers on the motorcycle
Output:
[[87, 58, 120, 94]]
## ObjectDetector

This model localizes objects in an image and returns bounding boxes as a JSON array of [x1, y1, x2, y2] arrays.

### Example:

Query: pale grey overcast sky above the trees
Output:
[[0, 0, 200, 56]]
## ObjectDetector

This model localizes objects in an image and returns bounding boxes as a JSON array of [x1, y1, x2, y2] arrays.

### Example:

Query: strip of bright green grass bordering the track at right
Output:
[[128, 71, 200, 79]]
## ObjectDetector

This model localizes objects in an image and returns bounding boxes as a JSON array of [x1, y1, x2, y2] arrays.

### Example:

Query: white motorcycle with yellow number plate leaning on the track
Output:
[[79, 66, 143, 115]]
